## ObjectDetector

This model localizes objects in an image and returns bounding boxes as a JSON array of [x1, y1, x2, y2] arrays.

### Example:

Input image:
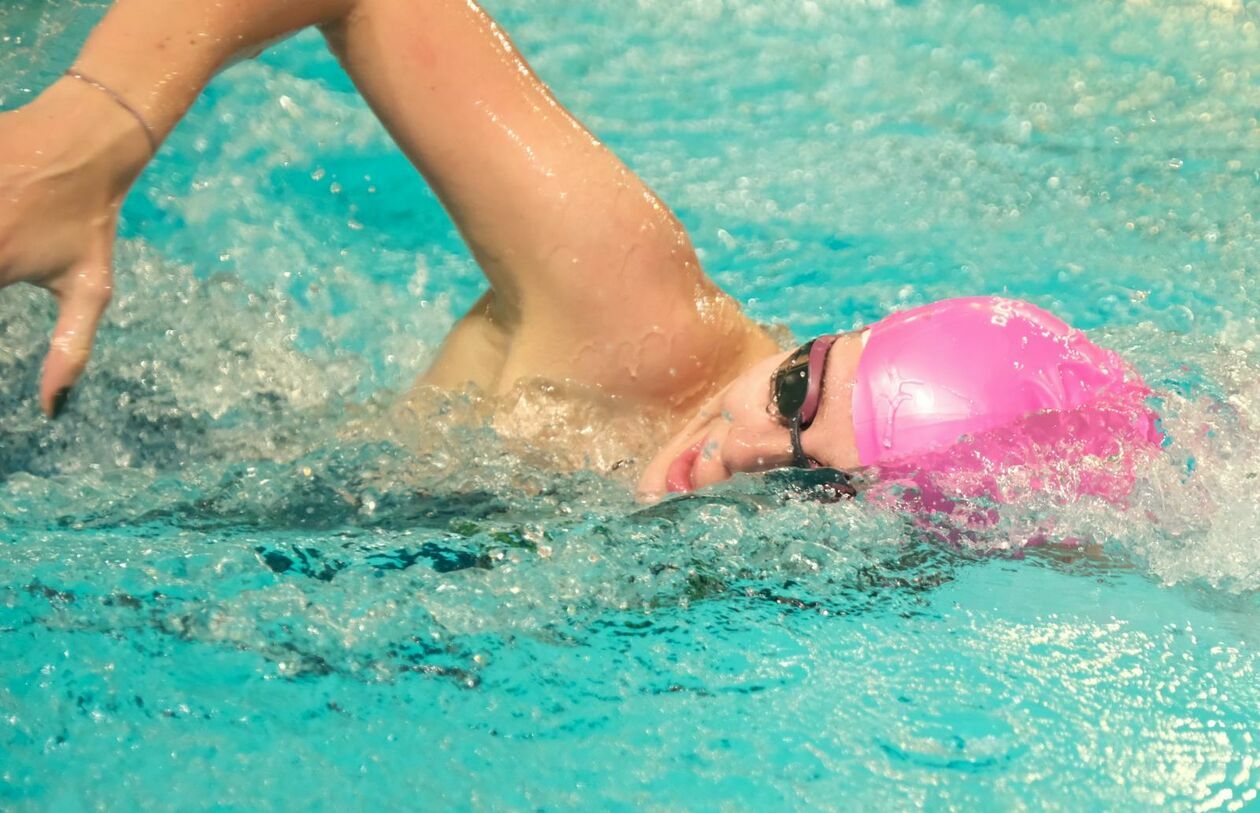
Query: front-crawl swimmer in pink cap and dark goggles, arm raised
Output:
[[0, 0, 1158, 500]]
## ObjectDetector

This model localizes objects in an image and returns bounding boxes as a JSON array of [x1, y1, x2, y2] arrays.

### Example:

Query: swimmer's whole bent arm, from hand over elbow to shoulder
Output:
[[0, 0, 766, 410]]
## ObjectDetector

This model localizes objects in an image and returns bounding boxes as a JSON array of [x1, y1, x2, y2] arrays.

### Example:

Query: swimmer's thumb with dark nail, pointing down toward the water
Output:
[[39, 251, 113, 418]]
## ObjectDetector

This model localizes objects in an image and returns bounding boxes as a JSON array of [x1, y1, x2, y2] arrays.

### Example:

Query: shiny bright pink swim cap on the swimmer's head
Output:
[[853, 296, 1163, 499]]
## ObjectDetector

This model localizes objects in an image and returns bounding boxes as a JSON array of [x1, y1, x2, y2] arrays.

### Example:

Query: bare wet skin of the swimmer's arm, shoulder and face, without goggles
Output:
[[0, 0, 861, 499]]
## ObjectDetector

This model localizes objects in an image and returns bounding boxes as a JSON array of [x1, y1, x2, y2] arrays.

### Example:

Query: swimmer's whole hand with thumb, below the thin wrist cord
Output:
[[0, 79, 149, 417]]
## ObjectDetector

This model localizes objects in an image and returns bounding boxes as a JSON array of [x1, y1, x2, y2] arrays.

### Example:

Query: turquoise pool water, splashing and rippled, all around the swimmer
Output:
[[0, 0, 1260, 810]]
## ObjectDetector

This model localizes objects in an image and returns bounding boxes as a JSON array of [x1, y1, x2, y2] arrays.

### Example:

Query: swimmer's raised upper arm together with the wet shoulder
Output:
[[326, 0, 766, 401]]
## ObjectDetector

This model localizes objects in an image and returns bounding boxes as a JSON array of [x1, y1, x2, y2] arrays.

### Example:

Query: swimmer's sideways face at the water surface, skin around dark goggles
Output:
[[638, 334, 861, 500]]
